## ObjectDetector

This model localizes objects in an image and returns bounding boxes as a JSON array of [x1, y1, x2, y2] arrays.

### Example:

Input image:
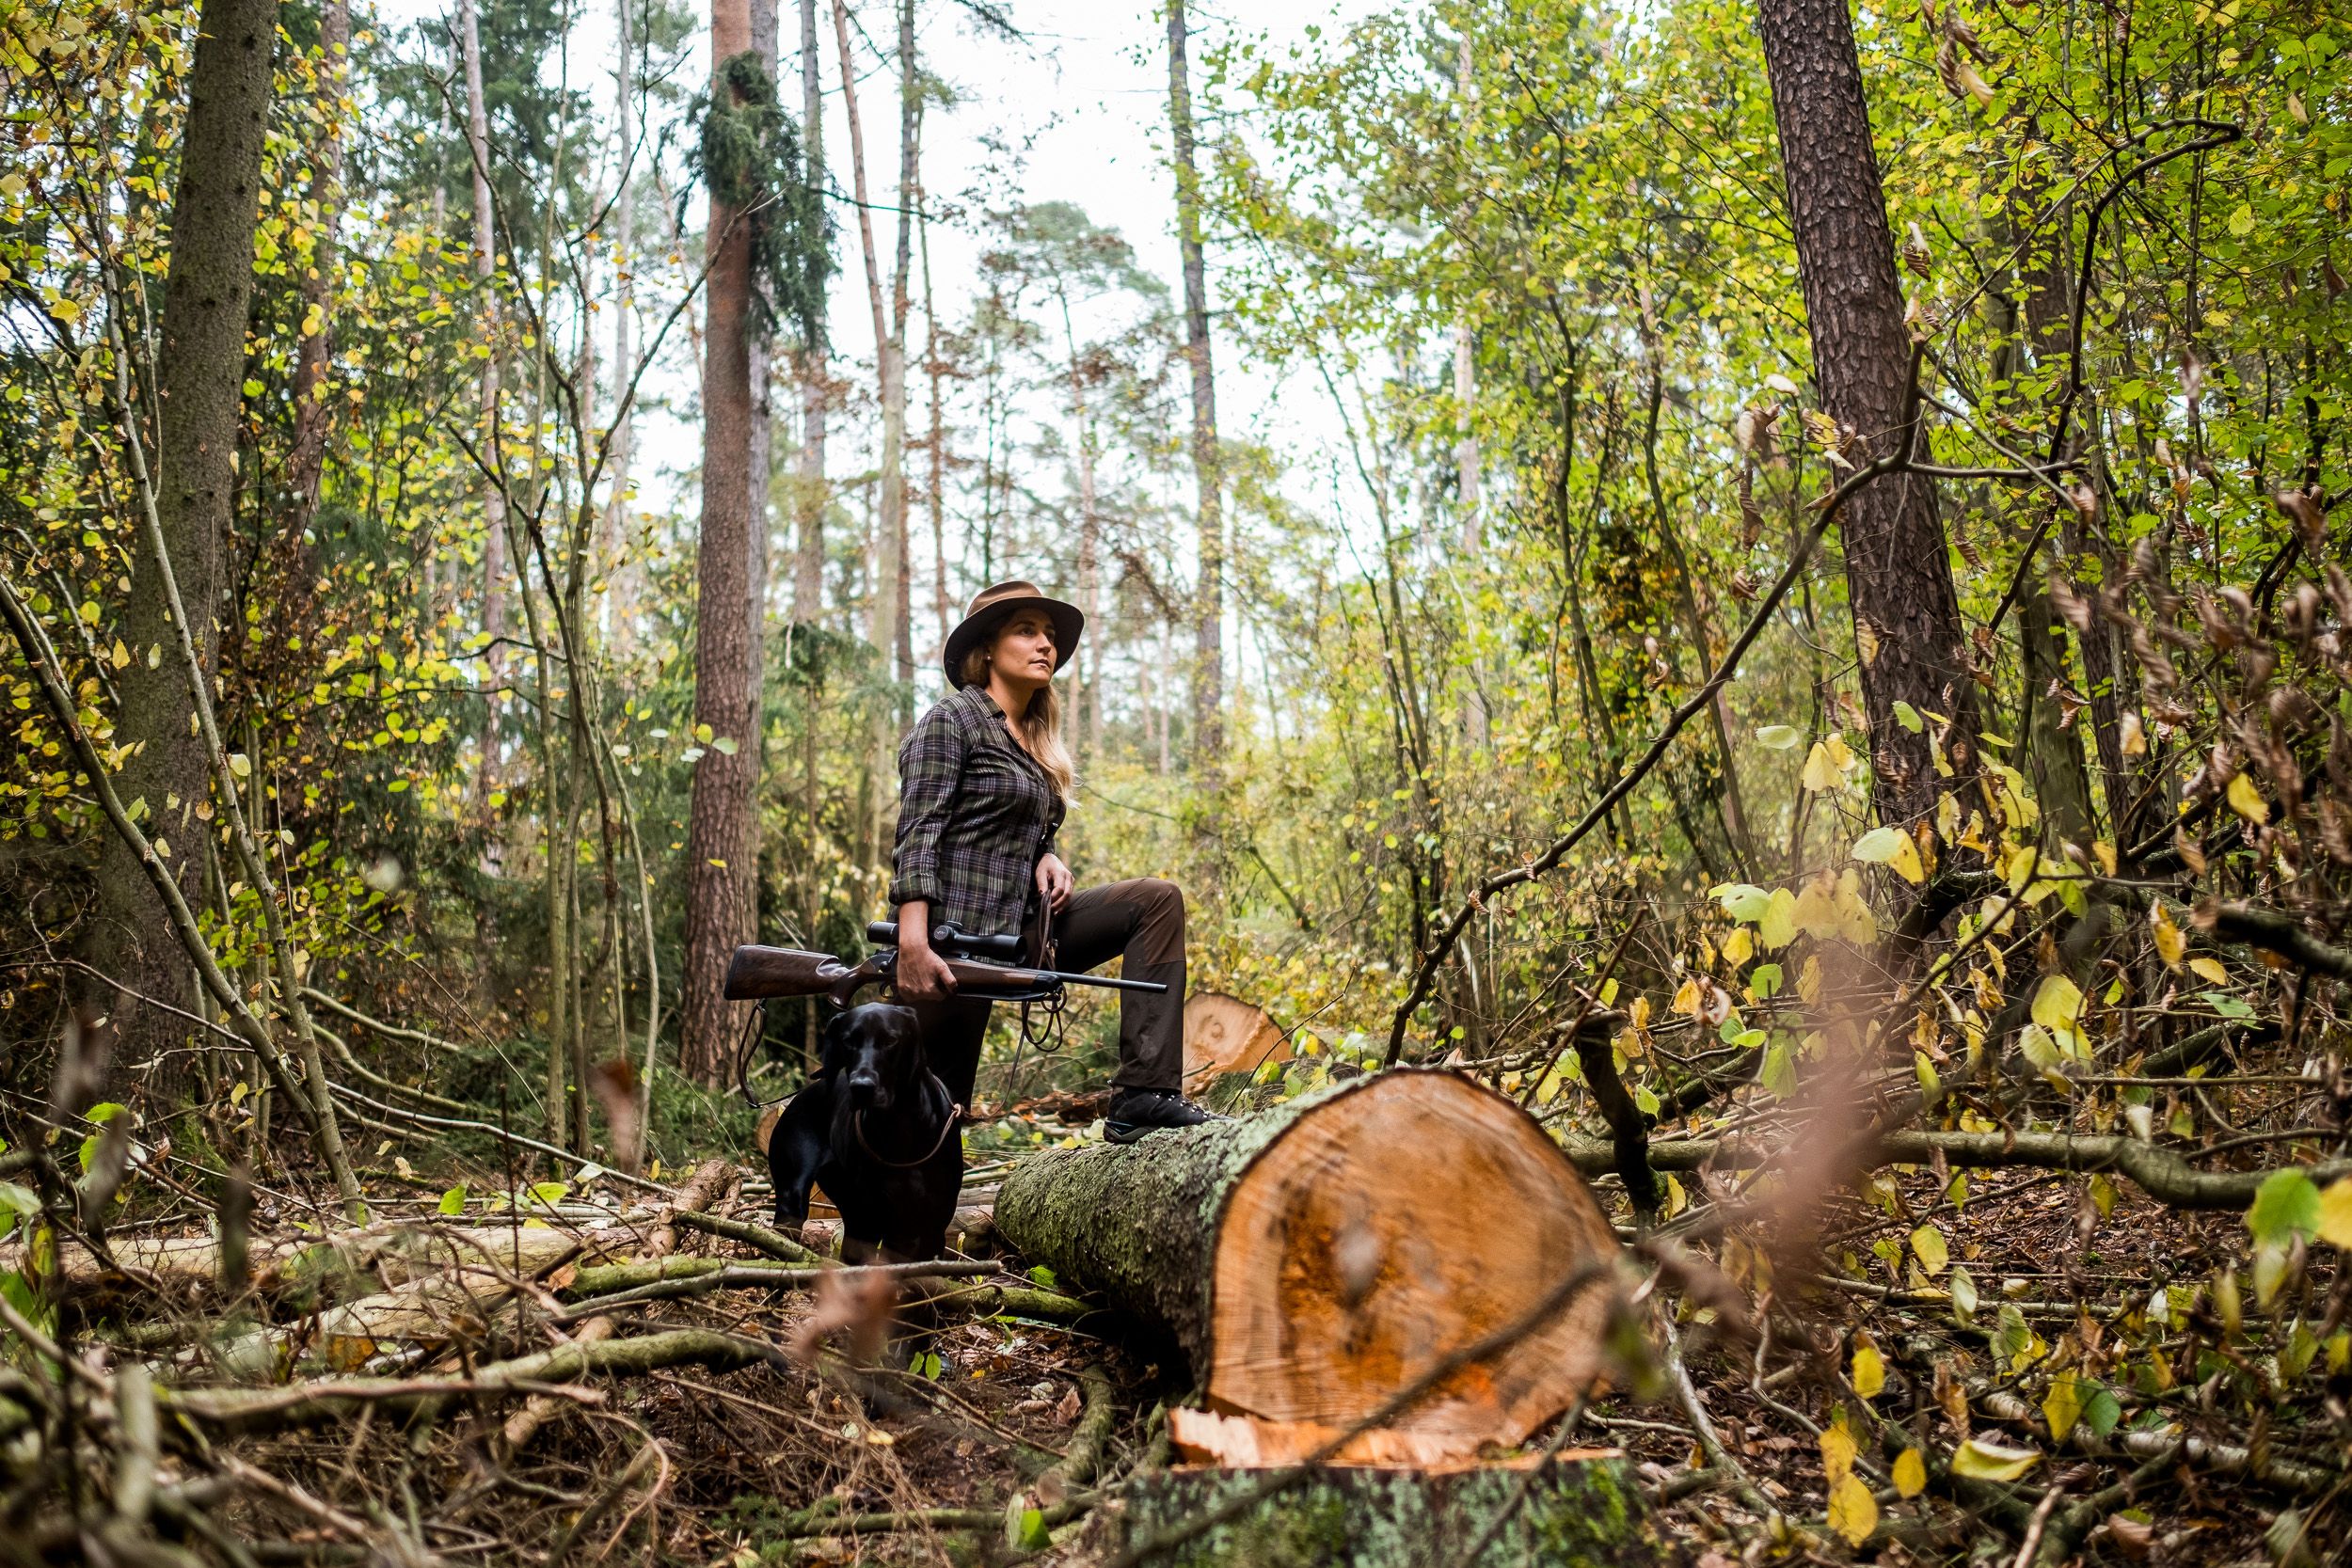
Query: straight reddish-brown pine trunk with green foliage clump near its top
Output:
[[680, 0, 757, 1084]]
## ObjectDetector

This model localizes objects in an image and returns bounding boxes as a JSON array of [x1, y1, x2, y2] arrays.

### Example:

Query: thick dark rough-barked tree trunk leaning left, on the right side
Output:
[[1757, 0, 1979, 823]]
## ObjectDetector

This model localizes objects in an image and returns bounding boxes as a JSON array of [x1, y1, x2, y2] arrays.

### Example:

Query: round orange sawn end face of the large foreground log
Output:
[[1209, 1072, 1616, 1453]]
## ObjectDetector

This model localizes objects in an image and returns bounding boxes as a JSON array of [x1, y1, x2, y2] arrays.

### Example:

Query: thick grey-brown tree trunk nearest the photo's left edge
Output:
[[89, 0, 278, 1088]]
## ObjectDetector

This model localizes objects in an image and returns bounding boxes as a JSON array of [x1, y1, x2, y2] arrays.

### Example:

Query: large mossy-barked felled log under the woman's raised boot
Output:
[[997, 1069, 1616, 1453]]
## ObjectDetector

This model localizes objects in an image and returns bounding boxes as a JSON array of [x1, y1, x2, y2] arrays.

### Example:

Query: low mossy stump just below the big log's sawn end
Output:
[[1124, 1455, 1673, 1568]]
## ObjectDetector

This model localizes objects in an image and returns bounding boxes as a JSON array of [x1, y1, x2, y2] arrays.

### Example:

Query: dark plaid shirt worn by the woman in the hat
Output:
[[889, 687, 1063, 936]]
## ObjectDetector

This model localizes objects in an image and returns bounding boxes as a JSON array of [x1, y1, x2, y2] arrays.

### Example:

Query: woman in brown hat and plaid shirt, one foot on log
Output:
[[889, 583, 1214, 1143]]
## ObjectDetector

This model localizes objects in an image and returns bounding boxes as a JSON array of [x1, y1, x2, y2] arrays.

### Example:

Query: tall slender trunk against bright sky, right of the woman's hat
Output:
[[1169, 0, 1226, 770]]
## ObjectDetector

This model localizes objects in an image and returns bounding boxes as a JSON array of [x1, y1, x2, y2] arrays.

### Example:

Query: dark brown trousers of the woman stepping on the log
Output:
[[915, 877, 1184, 1105]]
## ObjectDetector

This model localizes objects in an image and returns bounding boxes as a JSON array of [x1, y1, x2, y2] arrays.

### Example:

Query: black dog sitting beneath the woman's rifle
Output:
[[767, 1002, 964, 1262]]
